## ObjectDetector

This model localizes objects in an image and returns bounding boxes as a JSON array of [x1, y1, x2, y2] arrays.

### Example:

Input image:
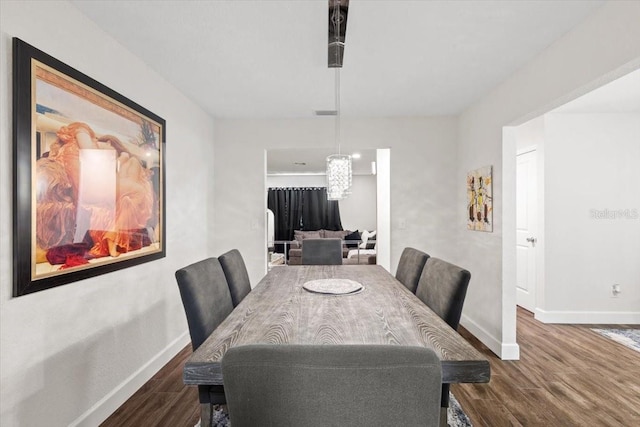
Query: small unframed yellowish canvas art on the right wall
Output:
[[466, 166, 493, 232]]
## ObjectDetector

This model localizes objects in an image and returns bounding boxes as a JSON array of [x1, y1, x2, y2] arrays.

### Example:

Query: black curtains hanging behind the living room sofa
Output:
[[267, 188, 342, 249]]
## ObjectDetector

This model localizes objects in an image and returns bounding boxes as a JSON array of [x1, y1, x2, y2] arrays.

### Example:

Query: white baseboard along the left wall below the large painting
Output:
[[69, 331, 191, 427]]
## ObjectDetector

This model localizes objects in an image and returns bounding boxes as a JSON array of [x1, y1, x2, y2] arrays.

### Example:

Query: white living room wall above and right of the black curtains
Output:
[[267, 175, 376, 231]]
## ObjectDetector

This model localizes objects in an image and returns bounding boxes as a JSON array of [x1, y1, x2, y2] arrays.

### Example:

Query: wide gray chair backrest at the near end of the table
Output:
[[222, 344, 442, 427]]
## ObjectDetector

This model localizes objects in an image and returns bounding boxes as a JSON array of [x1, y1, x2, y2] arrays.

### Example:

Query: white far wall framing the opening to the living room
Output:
[[214, 117, 464, 283]]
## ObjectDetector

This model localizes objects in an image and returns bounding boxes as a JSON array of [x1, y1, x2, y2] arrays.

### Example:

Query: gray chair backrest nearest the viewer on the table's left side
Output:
[[176, 258, 233, 350]]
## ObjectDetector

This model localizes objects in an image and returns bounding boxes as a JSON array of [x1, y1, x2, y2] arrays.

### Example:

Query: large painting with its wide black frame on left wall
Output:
[[13, 38, 166, 296]]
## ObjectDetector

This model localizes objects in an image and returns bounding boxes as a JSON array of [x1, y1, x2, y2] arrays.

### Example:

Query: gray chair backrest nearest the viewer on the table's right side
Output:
[[416, 257, 471, 329]]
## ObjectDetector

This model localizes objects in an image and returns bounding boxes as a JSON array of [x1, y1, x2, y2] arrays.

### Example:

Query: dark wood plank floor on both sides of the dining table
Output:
[[101, 308, 640, 427]]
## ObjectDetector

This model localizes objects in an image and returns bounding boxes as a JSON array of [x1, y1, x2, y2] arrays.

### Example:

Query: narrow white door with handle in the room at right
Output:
[[516, 150, 538, 312]]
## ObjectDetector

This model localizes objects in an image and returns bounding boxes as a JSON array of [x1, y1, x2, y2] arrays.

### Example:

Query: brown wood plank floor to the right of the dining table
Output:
[[451, 308, 640, 427]]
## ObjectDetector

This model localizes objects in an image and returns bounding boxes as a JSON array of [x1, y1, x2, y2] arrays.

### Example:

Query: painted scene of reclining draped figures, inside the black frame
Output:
[[35, 65, 160, 273]]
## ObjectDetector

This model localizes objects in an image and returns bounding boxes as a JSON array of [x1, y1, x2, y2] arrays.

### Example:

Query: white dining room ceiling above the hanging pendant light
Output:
[[72, 0, 604, 118]]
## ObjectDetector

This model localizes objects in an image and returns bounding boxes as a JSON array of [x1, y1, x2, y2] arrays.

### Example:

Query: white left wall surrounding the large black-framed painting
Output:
[[0, 0, 213, 427]]
